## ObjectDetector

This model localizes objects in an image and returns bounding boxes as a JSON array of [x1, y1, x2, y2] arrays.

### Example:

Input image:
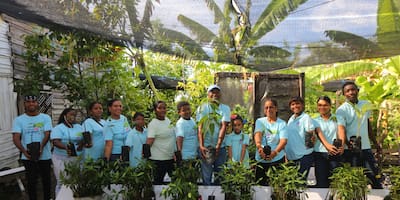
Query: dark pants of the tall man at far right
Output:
[[343, 149, 382, 189]]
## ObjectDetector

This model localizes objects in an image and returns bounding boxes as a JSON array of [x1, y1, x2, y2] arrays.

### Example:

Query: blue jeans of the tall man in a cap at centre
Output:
[[201, 147, 226, 185]]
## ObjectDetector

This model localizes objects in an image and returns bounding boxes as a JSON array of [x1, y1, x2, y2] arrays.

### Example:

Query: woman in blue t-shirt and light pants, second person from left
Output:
[[50, 108, 83, 196]]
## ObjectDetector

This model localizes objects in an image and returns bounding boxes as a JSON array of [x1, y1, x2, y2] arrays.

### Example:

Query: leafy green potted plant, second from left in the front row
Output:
[[112, 160, 155, 200]]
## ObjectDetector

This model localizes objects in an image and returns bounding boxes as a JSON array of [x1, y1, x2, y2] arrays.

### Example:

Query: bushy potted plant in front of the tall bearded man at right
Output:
[[329, 163, 368, 200]]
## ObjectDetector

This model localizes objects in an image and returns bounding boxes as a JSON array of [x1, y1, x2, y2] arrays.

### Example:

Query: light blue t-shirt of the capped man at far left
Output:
[[12, 113, 52, 160]]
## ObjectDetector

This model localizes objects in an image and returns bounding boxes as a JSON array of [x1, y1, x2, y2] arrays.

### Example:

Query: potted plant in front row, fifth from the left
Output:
[[266, 162, 307, 200]]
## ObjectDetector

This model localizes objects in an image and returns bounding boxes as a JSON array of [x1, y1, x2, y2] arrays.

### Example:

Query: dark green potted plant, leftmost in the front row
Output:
[[60, 157, 110, 199]]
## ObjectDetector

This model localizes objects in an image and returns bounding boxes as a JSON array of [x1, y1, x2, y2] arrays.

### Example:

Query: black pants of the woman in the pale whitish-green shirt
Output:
[[150, 160, 174, 185]]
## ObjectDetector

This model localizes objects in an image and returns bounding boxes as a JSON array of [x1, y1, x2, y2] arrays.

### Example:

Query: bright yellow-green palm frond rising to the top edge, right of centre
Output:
[[251, 0, 307, 40]]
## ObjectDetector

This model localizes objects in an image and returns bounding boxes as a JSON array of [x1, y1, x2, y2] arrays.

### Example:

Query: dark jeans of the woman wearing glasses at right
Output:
[[313, 152, 340, 188]]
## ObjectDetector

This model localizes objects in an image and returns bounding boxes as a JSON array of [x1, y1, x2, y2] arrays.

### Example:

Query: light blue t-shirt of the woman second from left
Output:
[[50, 123, 83, 156]]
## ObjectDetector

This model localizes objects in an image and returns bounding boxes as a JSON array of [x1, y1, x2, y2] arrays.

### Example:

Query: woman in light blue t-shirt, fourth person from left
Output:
[[103, 99, 131, 161]]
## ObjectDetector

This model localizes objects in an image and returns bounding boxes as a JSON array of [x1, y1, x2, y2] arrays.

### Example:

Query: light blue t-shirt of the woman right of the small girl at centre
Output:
[[254, 117, 288, 163]]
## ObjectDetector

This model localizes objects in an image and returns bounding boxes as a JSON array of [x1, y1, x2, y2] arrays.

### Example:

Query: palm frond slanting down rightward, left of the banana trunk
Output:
[[178, 15, 217, 43]]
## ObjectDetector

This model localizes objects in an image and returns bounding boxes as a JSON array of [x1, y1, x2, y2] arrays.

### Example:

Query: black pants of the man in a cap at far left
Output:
[[22, 160, 52, 200]]
